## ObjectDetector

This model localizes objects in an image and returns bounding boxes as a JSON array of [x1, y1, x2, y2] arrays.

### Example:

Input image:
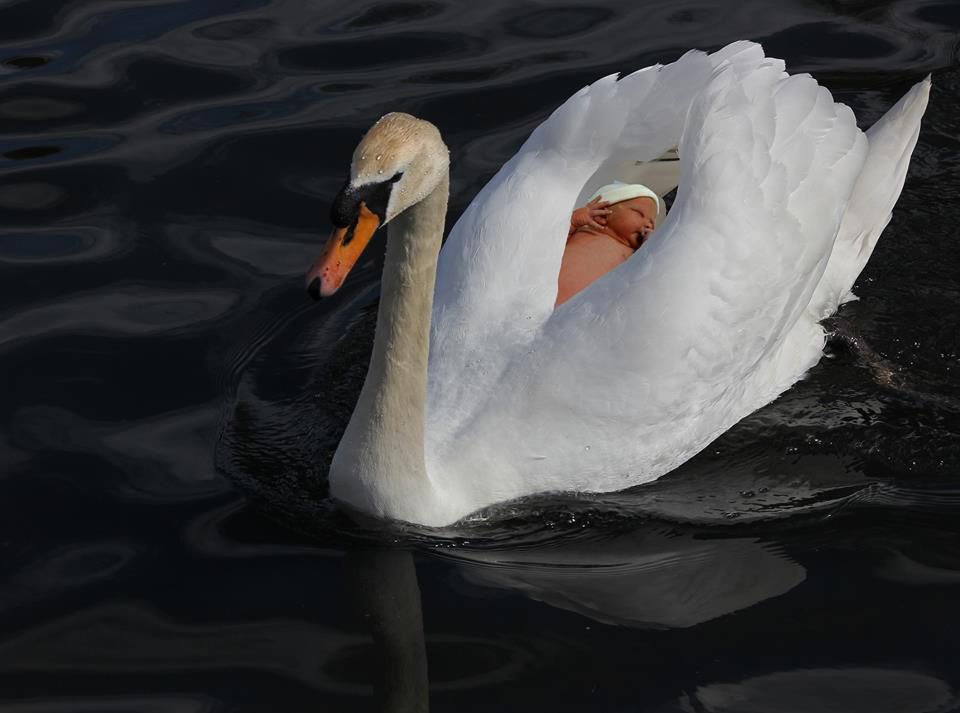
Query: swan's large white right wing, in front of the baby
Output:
[[441, 55, 867, 502]]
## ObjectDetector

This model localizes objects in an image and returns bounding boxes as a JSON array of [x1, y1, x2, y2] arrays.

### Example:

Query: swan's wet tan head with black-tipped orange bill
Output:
[[307, 112, 450, 298]]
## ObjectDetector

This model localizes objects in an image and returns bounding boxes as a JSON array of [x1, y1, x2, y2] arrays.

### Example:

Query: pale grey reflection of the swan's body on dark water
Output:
[[446, 531, 806, 628]]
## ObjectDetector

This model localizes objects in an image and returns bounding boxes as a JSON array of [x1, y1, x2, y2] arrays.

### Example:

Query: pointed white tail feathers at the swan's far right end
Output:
[[809, 76, 931, 320]]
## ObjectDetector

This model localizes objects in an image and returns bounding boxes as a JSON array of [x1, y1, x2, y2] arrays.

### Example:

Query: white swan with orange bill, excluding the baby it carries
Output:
[[307, 42, 930, 526]]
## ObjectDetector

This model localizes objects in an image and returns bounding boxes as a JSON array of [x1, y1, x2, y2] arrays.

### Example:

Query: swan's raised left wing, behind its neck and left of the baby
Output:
[[428, 42, 764, 444]]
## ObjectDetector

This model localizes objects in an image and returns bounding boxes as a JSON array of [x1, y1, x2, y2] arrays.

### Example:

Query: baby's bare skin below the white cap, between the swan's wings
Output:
[[556, 196, 657, 305]]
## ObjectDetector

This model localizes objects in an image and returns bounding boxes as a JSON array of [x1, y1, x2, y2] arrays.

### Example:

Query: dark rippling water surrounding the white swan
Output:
[[0, 0, 960, 713]]
